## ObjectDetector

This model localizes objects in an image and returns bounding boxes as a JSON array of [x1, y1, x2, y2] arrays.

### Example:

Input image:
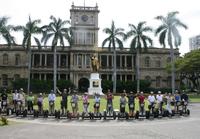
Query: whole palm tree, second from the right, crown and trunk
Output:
[[125, 22, 153, 92]]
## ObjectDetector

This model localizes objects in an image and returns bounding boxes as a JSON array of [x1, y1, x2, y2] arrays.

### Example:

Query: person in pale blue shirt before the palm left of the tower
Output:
[[48, 90, 56, 115]]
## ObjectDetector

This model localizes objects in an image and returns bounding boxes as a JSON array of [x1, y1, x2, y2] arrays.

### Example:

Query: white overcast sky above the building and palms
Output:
[[0, 0, 200, 54]]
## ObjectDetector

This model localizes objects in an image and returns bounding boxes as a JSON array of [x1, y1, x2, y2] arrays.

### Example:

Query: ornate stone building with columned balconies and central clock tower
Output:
[[0, 5, 179, 88]]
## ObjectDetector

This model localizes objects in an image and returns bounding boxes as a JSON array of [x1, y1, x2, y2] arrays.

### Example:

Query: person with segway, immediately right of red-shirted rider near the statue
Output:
[[118, 93, 129, 120]]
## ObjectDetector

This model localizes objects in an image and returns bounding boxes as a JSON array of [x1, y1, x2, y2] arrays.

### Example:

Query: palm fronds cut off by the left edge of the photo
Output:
[[0, 17, 15, 47]]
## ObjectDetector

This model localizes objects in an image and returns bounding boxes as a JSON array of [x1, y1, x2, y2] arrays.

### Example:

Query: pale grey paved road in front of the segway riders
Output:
[[0, 104, 200, 139]]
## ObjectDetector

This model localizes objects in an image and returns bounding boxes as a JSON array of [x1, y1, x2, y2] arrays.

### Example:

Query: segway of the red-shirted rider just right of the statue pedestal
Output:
[[103, 103, 116, 120]]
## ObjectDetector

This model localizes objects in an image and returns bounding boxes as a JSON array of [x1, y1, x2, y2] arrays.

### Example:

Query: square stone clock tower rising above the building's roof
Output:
[[70, 4, 99, 47]]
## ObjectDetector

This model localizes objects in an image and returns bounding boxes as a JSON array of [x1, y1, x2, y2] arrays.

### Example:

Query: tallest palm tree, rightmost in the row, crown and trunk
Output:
[[155, 11, 187, 93]]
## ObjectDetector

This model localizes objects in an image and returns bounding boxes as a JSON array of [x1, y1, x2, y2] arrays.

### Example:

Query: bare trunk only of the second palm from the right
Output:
[[136, 49, 140, 93]]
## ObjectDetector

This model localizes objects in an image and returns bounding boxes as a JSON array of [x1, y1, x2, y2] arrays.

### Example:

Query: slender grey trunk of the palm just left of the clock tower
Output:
[[53, 47, 57, 93]]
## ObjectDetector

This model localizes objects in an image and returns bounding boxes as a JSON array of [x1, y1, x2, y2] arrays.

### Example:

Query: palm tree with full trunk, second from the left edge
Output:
[[16, 16, 42, 93]]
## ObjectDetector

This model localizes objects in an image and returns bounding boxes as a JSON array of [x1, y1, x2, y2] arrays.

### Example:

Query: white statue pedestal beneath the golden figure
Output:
[[88, 73, 104, 95]]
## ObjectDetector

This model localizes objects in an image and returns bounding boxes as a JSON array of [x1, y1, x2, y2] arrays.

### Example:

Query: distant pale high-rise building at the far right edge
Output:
[[189, 35, 200, 51]]
